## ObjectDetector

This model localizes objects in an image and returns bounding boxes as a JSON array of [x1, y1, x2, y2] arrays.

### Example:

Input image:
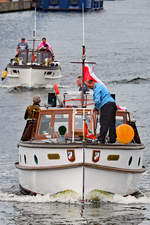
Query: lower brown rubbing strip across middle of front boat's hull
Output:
[[15, 162, 145, 174]]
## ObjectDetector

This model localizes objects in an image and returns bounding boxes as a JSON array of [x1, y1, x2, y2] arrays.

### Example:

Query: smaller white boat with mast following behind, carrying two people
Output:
[[1, 9, 62, 88]]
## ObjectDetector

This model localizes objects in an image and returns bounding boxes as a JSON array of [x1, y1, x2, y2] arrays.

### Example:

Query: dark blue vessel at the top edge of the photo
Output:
[[35, 0, 103, 11]]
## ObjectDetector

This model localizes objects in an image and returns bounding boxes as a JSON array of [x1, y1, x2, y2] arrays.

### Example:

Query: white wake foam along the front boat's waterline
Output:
[[0, 187, 150, 205]]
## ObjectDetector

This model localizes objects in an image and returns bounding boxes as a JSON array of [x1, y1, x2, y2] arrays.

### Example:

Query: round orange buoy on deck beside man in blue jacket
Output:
[[116, 124, 135, 144]]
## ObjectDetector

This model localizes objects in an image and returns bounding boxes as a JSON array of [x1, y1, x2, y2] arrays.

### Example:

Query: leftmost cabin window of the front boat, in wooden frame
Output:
[[39, 115, 51, 135]]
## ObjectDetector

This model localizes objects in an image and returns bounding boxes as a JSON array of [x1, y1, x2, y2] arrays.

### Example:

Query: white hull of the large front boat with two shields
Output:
[[16, 143, 144, 199]]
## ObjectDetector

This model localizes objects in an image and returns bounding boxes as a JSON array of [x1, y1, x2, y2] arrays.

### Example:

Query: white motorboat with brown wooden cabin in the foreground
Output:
[[15, 89, 145, 199]]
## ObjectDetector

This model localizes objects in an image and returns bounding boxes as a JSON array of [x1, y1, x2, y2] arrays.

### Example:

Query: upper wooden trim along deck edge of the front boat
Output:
[[18, 141, 145, 150]]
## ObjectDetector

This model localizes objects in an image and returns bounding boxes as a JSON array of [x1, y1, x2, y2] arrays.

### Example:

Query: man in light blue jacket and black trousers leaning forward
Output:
[[86, 79, 117, 144]]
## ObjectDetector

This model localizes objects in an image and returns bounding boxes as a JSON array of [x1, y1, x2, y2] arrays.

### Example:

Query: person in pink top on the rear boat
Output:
[[37, 37, 54, 60]]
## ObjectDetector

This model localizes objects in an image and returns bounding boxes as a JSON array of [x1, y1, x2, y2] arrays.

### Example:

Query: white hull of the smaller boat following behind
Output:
[[4, 65, 61, 88]]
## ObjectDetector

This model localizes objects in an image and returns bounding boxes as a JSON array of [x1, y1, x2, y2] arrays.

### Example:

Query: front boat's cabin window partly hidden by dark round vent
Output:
[[53, 114, 69, 135]]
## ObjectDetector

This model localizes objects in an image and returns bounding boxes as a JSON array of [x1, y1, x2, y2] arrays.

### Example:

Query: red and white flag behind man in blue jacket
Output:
[[84, 63, 106, 87]]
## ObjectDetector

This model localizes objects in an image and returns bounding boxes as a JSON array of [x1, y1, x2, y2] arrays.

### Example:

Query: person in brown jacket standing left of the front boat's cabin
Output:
[[24, 96, 41, 120]]
